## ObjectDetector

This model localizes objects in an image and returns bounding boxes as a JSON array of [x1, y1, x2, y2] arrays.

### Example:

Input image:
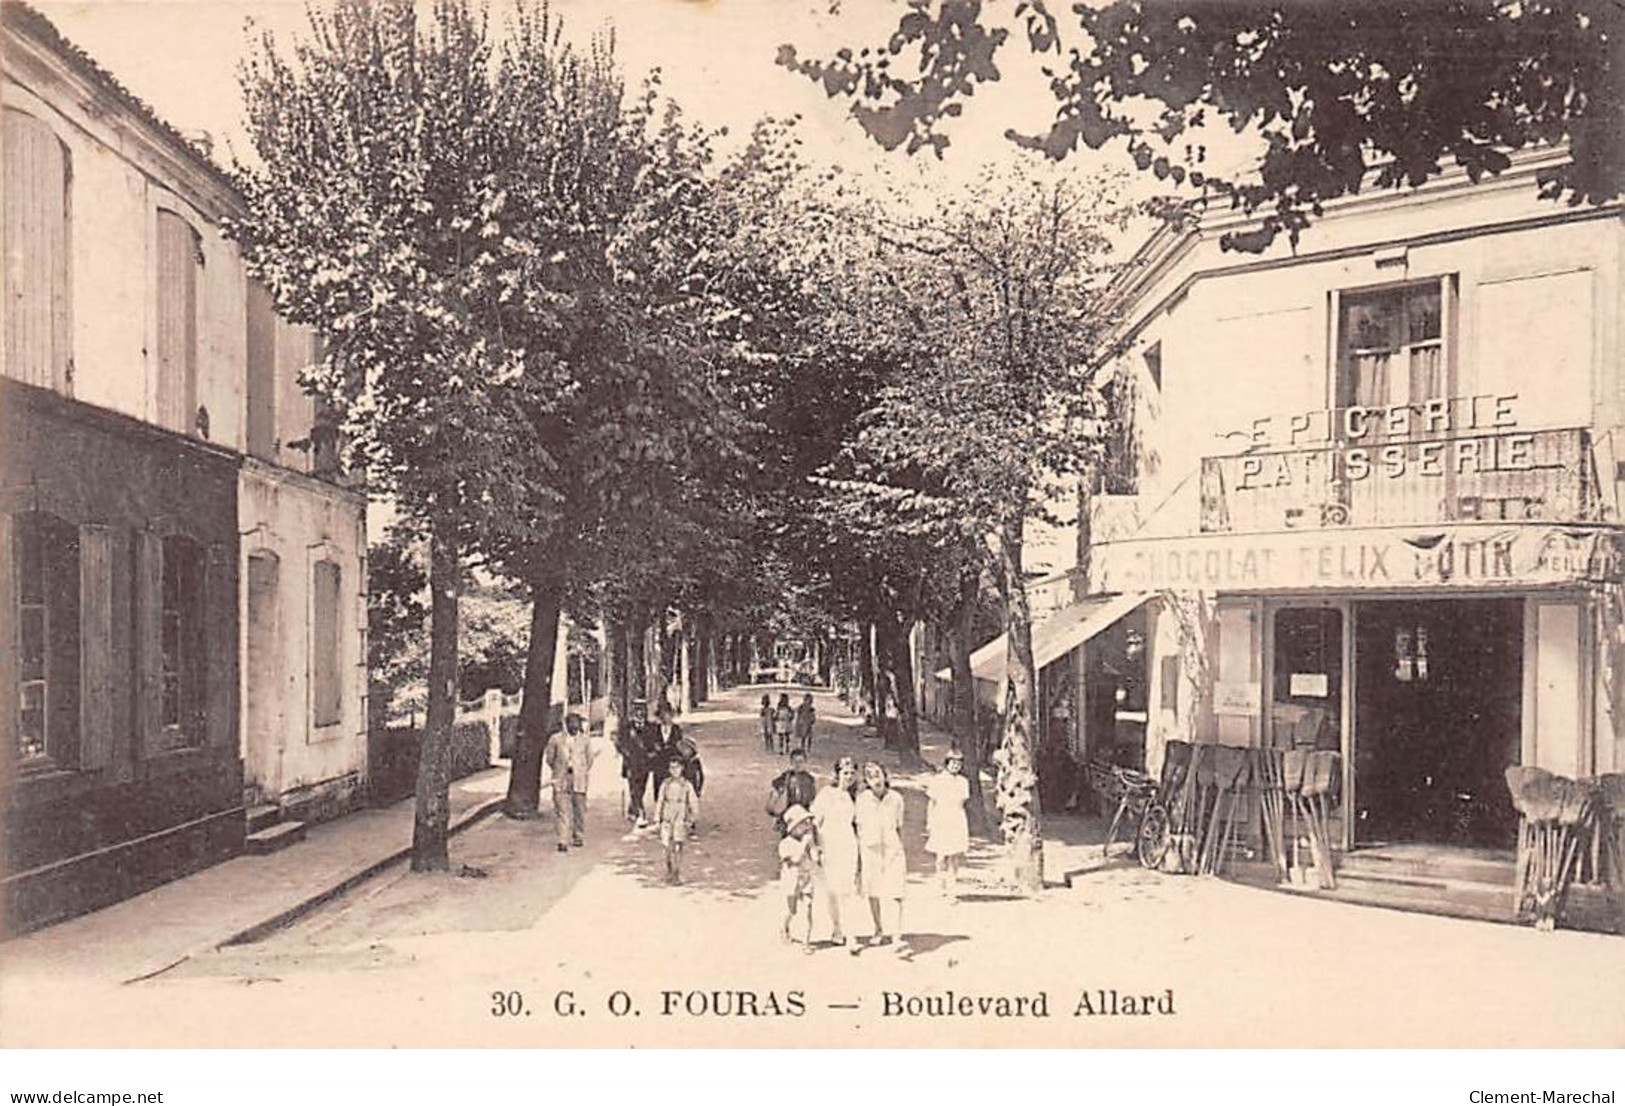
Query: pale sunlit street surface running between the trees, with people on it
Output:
[[0, 689, 1625, 1048]]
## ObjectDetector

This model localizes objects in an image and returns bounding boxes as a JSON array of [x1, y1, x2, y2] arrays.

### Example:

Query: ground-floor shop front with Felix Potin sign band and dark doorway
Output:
[[1090, 523, 1622, 901]]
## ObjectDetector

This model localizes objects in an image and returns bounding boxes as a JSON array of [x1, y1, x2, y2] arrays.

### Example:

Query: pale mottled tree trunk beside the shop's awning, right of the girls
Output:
[[996, 500, 1043, 895]]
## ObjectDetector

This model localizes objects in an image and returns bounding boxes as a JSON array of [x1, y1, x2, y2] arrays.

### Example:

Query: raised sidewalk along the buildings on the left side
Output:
[[0, 765, 509, 983]]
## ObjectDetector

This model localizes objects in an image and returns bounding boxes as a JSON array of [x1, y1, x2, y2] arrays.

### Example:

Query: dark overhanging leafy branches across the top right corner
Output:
[[780, 0, 1625, 250]]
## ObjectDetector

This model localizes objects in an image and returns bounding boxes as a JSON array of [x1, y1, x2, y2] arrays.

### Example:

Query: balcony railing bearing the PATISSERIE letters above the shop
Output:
[[1201, 429, 1602, 533]]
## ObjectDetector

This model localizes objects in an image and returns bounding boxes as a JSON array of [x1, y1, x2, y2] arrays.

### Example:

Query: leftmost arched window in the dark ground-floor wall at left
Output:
[[11, 512, 80, 765]]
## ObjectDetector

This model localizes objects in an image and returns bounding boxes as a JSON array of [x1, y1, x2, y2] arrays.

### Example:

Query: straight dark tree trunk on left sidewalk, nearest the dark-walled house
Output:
[[411, 515, 463, 872]]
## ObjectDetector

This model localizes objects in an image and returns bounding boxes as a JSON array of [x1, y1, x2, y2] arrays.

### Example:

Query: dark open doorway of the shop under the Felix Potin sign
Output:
[[1354, 599, 1523, 849]]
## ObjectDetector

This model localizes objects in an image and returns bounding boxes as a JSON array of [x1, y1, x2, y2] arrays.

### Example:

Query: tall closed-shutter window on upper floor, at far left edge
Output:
[[0, 107, 72, 391]]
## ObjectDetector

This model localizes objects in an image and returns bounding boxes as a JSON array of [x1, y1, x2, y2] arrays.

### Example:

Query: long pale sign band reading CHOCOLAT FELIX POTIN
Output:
[[1090, 525, 1625, 591]]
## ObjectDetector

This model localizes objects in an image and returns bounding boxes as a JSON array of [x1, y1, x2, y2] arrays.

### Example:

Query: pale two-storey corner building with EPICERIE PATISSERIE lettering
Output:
[[1084, 153, 1625, 889]]
